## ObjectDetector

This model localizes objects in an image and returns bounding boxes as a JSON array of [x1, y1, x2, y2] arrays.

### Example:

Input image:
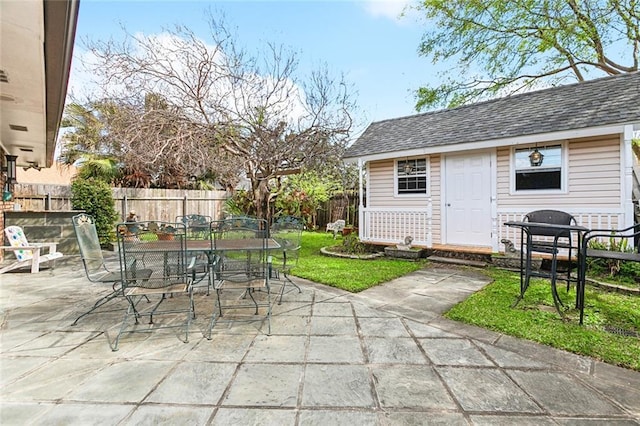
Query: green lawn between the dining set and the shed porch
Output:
[[291, 232, 426, 293]]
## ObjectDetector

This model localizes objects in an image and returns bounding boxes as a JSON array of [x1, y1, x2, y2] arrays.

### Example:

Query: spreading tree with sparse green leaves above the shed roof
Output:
[[416, 0, 640, 111]]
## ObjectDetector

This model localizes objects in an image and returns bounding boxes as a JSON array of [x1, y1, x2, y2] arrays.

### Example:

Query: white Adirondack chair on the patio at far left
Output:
[[0, 226, 63, 274]]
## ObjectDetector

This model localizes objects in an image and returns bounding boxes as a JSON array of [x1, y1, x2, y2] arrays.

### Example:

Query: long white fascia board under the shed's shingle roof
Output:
[[344, 123, 640, 163]]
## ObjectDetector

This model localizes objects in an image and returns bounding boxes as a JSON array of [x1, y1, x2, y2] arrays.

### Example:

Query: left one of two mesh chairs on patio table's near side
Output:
[[112, 222, 195, 351]]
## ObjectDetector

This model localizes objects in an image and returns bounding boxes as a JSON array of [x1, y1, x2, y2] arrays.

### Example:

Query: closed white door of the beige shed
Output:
[[443, 152, 491, 246]]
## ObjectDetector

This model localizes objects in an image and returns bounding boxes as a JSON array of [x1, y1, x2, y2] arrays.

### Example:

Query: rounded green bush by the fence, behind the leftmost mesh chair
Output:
[[71, 179, 118, 245]]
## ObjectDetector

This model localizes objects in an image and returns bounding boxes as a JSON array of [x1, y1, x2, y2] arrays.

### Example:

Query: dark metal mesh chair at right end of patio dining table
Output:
[[269, 216, 304, 304]]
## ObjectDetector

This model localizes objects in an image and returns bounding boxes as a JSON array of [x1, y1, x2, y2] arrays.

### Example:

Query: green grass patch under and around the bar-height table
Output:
[[445, 269, 640, 371]]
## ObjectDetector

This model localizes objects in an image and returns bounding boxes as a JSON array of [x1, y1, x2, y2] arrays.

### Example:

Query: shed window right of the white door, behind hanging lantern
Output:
[[515, 145, 562, 191]]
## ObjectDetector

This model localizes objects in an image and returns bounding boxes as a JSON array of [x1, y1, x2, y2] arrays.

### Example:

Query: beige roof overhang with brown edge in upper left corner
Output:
[[0, 0, 80, 167]]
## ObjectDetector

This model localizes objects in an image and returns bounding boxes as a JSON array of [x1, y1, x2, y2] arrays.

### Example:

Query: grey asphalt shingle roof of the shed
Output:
[[345, 72, 640, 158]]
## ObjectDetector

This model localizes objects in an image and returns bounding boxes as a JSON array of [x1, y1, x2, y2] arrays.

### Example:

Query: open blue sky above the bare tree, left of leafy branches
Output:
[[69, 0, 436, 126]]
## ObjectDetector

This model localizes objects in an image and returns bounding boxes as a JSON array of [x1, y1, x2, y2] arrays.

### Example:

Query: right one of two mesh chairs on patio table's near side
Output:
[[207, 219, 271, 339]]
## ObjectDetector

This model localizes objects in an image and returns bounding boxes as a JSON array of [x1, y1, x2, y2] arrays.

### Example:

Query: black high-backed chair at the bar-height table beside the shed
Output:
[[514, 210, 580, 312]]
